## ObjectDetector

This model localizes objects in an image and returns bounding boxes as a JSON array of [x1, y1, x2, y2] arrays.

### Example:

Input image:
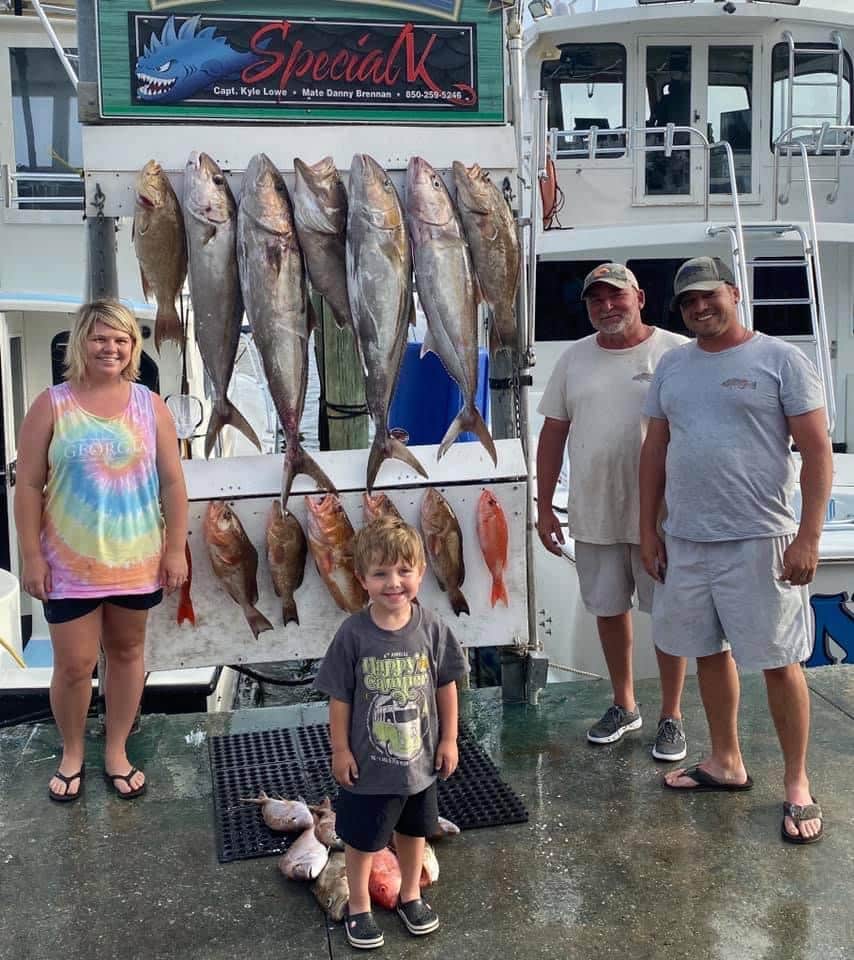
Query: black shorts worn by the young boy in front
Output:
[[335, 780, 439, 853]]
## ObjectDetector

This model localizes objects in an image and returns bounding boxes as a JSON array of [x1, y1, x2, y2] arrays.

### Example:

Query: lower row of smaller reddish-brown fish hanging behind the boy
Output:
[[196, 487, 509, 638]]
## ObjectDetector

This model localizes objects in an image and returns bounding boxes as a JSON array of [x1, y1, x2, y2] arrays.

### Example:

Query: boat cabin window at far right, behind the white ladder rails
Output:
[[771, 41, 851, 153]]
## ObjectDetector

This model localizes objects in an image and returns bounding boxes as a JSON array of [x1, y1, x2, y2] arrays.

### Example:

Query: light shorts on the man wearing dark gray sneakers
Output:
[[575, 540, 655, 617]]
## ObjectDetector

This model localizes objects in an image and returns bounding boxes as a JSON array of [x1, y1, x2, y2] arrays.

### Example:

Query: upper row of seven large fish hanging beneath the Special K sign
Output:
[[134, 152, 521, 496]]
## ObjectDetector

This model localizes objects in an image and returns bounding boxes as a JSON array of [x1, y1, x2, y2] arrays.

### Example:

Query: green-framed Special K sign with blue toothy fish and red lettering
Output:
[[99, 0, 504, 123]]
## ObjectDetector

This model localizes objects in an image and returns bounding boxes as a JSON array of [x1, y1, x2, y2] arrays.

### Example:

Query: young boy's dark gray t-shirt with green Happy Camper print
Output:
[[314, 603, 468, 796]]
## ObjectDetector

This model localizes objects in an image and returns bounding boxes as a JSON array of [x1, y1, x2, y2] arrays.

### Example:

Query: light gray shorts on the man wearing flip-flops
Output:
[[652, 535, 810, 670]]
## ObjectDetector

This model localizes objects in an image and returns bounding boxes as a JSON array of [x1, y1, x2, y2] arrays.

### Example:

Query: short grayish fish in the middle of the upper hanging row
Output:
[[294, 157, 353, 327]]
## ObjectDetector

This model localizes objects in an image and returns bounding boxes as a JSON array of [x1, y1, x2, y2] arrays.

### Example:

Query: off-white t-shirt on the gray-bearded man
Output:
[[537, 327, 687, 543]]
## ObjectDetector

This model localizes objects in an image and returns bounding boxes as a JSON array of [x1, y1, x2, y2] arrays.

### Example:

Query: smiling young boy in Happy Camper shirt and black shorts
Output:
[[315, 517, 468, 949]]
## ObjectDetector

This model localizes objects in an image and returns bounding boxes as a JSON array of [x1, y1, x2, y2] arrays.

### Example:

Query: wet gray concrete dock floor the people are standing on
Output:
[[0, 666, 854, 960]]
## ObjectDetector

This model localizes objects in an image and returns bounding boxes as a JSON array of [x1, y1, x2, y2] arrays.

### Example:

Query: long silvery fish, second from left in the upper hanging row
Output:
[[184, 150, 261, 457]]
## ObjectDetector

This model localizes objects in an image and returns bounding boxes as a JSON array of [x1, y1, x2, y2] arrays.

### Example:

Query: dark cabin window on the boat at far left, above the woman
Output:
[[9, 47, 83, 210]]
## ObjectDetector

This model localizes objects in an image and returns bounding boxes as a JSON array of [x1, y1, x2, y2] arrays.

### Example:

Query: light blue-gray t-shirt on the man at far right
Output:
[[644, 333, 824, 541]]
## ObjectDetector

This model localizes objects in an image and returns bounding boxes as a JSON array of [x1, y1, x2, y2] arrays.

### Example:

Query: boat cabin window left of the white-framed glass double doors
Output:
[[540, 43, 626, 160]]
